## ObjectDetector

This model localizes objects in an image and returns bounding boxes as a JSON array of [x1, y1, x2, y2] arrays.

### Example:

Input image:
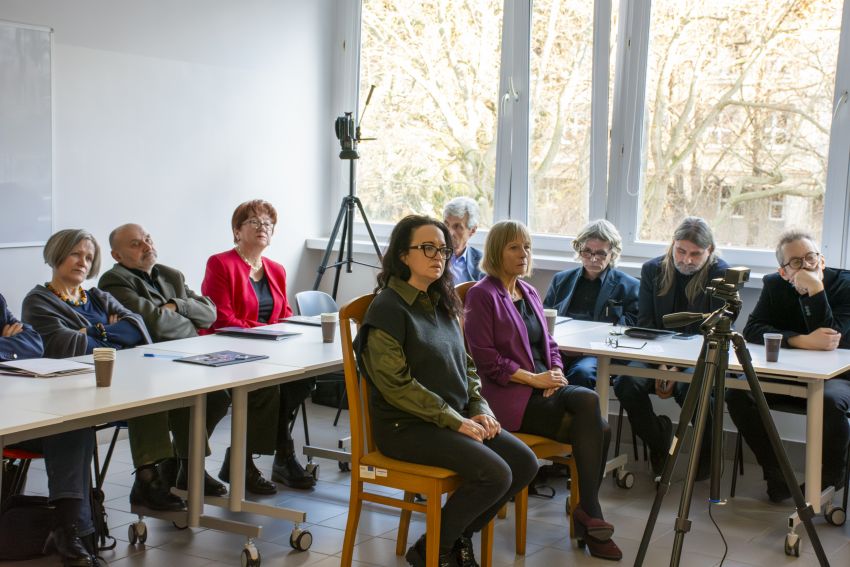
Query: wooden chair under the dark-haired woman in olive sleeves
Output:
[[339, 294, 493, 567]]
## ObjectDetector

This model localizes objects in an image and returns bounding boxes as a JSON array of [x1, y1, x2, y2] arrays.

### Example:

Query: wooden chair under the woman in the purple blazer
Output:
[[455, 282, 579, 555]]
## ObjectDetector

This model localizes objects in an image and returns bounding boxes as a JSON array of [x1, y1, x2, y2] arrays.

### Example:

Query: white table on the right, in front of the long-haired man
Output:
[[554, 321, 850, 556]]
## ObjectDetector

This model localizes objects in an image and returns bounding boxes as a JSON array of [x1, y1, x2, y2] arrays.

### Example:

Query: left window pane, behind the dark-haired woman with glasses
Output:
[[357, 0, 502, 225]]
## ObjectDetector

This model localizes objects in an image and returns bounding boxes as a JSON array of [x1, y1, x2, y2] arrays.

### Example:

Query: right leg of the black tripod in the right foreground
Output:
[[732, 333, 829, 567]]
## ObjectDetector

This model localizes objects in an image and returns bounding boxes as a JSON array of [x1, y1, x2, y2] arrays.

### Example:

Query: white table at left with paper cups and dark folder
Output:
[[0, 347, 306, 564]]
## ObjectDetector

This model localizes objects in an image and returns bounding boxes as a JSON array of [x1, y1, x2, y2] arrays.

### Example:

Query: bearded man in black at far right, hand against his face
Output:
[[726, 230, 850, 503]]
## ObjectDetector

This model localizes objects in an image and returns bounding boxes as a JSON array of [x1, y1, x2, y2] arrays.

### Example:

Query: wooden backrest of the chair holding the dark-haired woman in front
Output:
[[339, 293, 375, 470]]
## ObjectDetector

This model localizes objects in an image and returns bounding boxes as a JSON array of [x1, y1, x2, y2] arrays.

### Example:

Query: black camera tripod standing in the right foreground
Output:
[[634, 302, 829, 567]]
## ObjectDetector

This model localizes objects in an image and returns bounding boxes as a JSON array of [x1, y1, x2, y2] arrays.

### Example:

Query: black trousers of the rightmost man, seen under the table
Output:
[[726, 374, 850, 488]]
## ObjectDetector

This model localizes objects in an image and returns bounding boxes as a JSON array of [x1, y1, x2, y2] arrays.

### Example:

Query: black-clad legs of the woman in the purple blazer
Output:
[[519, 385, 611, 519]]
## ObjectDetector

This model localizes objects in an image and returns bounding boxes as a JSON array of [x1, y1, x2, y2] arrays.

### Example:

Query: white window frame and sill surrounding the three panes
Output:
[[342, 0, 850, 271]]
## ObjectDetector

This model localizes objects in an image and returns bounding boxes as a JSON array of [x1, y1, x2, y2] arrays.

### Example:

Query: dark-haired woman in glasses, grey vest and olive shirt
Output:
[[355, 215, 537, 567]]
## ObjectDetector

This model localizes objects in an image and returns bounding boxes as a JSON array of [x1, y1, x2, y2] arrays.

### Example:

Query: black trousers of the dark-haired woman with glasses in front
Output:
[[373, 421, 538, 553]]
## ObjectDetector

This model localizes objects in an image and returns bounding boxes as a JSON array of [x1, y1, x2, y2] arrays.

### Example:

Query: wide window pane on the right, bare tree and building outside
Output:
[[638, 0, 842, 249]]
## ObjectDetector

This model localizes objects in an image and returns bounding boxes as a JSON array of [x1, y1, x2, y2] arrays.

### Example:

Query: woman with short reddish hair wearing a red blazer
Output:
[[201, 200, 316, 494]]
